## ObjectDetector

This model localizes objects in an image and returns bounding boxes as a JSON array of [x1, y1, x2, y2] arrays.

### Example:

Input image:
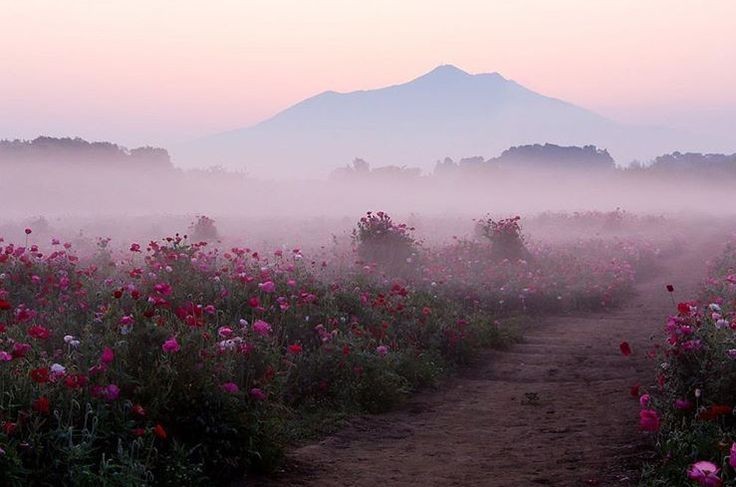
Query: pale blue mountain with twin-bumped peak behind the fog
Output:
[[173, 65, 720, 178]]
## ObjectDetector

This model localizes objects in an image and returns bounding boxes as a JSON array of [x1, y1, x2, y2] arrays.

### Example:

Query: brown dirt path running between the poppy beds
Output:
[[252, 248, 705, 487]]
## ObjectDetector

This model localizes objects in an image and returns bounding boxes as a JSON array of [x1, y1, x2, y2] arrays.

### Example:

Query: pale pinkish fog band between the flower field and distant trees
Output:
[[0, 158, 736, 254]]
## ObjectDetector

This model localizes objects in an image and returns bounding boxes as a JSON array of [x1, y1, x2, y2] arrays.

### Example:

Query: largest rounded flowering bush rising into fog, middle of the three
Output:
[[353, 211, 417, 271]]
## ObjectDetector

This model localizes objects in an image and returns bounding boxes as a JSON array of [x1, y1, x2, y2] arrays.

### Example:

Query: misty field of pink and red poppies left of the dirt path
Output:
[[0, 213, 660, 485]]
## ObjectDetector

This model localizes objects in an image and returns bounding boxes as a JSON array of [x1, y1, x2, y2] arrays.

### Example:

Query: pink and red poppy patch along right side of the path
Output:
[[639, 245, 736, 486]]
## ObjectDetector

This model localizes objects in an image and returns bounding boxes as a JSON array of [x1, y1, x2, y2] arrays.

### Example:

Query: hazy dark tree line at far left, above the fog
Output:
[[0, 137, 173, 170]]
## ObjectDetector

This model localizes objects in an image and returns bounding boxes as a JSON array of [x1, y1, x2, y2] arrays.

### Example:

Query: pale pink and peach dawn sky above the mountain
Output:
[[0, 0, 736, 146]]
